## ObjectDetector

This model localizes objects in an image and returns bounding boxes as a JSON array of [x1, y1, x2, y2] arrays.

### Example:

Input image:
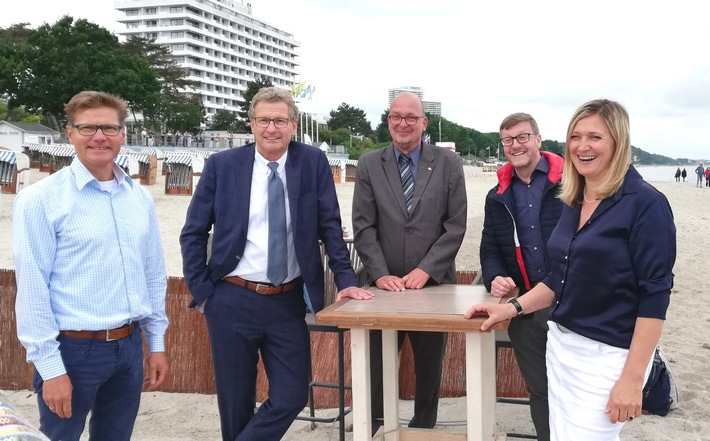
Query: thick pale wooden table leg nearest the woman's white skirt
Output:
[[466, 332, 496, 441]]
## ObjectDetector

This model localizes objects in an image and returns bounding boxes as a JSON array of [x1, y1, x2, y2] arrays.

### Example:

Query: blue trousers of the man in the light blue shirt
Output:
[[34, 324, 143, 441]]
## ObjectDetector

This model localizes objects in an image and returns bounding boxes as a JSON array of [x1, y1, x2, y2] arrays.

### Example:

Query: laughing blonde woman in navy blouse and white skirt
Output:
[[465, 99, 676, 441]]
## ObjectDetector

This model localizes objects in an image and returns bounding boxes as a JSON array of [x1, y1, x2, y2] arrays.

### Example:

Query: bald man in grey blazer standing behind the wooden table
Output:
[[352, 93, 466, 433]]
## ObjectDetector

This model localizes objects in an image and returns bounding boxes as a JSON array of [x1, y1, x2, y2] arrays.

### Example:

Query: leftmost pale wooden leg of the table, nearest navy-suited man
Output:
[[350, 328, 372, 441]]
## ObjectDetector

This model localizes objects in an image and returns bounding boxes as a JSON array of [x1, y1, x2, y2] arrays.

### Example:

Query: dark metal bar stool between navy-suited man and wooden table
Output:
[[296, 312, 352, 441]]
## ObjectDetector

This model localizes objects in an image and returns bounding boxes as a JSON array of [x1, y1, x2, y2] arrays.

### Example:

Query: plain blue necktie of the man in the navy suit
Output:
[[266, 162, 288, 286]]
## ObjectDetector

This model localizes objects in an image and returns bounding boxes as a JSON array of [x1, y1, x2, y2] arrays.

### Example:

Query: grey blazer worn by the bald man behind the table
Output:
[[352, 144, 467, 284]]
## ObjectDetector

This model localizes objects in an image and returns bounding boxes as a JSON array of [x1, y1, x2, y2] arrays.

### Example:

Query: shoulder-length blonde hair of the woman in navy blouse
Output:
[[560, 99, 631, 207]]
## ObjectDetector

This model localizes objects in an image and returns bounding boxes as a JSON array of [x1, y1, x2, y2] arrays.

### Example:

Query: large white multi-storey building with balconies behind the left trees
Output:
[[114, 0, 300, 119]]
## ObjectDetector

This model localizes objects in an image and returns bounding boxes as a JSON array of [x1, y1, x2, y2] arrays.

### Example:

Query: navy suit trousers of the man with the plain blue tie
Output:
[[205, 282, 311, 441]]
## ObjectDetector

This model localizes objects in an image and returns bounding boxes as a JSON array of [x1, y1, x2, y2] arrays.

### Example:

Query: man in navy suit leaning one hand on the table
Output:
[[180, 88, 372, 441]]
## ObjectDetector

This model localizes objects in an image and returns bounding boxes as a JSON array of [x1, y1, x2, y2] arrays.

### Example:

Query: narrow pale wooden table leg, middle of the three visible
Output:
[[382, 329, 399, 441]]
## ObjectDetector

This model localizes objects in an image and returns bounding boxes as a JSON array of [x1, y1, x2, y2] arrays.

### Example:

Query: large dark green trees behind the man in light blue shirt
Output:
[[0, 16, 205, 133]]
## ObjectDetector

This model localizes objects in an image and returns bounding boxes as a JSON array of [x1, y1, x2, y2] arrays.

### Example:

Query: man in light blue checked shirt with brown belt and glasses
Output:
[[13, 91, 168, 441]]
